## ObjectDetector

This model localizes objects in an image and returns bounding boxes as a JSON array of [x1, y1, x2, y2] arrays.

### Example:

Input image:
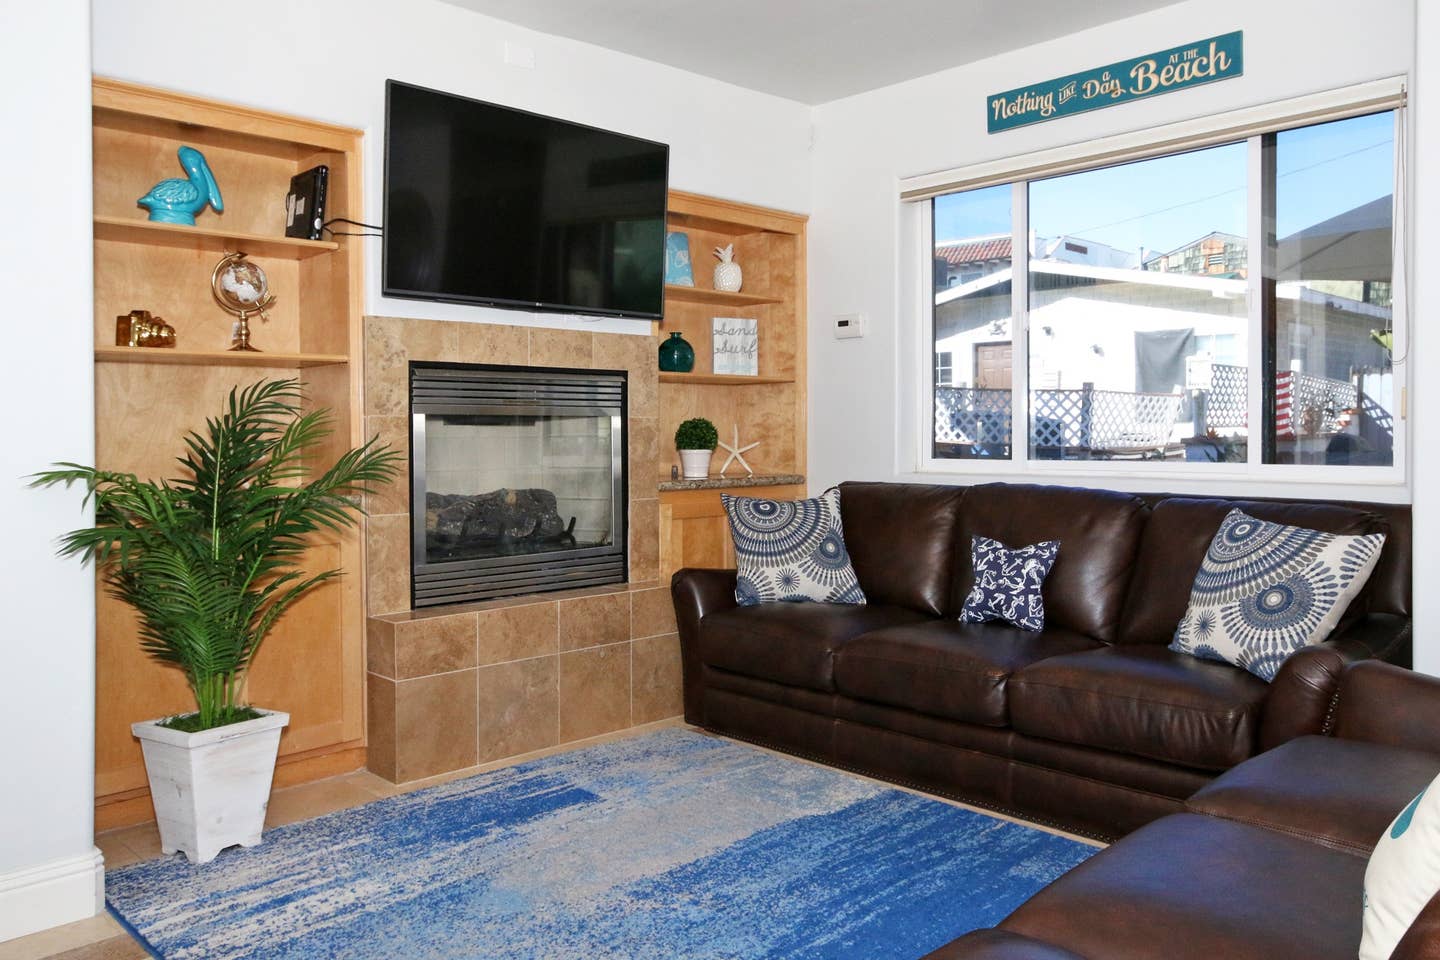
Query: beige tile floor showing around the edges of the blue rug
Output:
[[0, 720, 1099, 960]]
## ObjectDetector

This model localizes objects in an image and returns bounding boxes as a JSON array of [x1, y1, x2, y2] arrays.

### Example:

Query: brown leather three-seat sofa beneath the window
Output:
[[671, 484, 1410, 839]]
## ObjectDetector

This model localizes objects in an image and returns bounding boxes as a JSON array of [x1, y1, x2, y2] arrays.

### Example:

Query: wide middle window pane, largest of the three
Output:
[[1028, 142, 1248, 462]]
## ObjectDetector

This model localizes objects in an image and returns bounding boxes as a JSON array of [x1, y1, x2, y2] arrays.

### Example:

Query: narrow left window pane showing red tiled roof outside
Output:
[[932, 184, 1014, 459]]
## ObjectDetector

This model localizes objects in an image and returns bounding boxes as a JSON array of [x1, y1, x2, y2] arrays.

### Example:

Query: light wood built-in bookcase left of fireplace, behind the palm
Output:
[[94, 78, 364, 829]]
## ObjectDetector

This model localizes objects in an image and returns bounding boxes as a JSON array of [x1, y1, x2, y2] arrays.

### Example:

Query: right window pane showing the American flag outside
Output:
[[1261, 112, 1397, 466]]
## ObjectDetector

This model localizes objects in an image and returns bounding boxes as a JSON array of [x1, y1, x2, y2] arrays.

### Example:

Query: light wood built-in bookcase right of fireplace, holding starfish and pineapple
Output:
[[657, 190, 808, 579]]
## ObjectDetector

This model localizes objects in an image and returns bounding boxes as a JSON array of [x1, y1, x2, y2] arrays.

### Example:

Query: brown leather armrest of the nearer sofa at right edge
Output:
[[1331, 661, 1440, 754]]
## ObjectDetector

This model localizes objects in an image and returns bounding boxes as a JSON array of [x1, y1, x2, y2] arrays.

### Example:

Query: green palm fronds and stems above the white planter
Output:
[[32, 380, 400, 731]]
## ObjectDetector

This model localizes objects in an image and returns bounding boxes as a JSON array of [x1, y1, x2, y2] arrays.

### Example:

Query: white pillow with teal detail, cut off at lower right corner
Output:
[[1359, 777, 1440, 960]]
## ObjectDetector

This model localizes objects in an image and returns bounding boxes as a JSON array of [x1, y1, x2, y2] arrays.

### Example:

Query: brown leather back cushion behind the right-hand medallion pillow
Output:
[[1116, 497, 1388, 643]]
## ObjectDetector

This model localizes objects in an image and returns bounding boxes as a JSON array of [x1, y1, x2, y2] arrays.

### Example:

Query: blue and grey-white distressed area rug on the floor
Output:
[[107, 728, 1094, 960]]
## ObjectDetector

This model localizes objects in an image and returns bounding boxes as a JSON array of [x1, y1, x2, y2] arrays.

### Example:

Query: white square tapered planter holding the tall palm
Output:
[[130, 708, 289, 864]]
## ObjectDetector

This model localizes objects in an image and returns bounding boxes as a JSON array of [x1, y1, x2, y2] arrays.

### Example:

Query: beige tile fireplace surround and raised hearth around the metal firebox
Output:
[[364, 317, 681, 783]]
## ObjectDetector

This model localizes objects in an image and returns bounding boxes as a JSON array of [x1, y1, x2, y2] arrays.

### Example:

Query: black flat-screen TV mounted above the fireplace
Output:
[[382, 81, 670, 320]]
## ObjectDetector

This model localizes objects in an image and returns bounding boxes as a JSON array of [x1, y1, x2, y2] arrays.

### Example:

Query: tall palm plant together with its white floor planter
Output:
[[32, 380, 399, 864]]
